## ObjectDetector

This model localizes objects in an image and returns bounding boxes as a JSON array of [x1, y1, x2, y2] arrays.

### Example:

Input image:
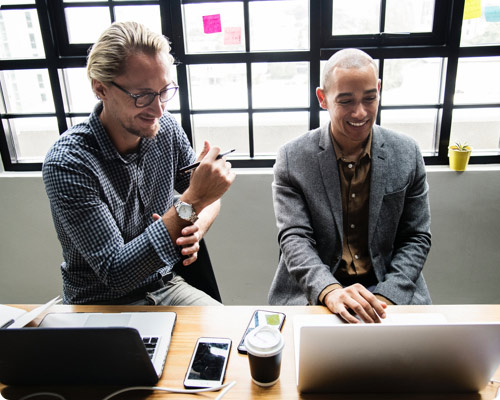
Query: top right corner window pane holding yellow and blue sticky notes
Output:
[[460, 0, 500, 46]]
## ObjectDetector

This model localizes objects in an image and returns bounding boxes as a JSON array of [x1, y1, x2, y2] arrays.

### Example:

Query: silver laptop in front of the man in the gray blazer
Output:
[[293, 314, 500, 393]]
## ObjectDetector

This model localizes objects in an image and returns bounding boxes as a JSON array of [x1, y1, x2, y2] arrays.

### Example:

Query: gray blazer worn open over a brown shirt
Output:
[[269, 124, 431, 305]]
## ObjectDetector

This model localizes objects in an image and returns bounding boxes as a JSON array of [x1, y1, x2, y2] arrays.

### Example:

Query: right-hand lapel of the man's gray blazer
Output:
[[368, 125, 388, 244]]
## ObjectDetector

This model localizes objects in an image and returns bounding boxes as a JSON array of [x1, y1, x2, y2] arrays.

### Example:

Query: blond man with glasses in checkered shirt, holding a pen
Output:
[[43, 22, 235, 305]]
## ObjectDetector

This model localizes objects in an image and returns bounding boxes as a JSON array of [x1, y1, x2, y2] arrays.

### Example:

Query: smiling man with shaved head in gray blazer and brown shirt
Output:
[[269, 49, 431, 323]]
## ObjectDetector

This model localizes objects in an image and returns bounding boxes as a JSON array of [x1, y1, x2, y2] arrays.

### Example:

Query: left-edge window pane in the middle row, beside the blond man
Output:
[[0, 69, 55, 114]]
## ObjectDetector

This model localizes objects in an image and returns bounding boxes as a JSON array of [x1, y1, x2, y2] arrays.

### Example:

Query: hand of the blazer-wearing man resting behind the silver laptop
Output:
[[323, 283, 387, 324]]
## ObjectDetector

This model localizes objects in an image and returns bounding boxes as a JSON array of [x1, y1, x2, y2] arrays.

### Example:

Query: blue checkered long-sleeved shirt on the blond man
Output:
[[42, 103, 196, 304]]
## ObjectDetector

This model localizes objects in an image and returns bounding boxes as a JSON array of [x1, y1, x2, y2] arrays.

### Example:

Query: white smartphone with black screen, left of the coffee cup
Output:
[[184, 337, 231, 388]]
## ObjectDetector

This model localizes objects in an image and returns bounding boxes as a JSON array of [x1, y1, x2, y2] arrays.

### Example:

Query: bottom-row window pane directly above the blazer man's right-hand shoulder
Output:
[[380, 110, 438, 153]]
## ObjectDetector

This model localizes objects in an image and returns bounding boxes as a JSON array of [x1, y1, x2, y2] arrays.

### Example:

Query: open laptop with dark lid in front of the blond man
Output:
[[0, 312, 176, 385]]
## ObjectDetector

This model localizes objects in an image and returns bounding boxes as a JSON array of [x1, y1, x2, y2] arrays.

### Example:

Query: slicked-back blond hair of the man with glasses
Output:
[[87, 21, 174, 88]]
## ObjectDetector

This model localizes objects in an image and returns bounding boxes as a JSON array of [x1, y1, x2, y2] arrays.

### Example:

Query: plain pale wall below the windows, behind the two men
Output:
[[0, 166, 500, 305]]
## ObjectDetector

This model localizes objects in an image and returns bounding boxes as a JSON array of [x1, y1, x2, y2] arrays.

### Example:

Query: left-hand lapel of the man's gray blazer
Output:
[[318, 124, 342, 237]]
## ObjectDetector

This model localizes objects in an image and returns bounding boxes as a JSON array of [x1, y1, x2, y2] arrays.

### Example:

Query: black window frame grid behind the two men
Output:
[[0, 0, 500, 171]]
